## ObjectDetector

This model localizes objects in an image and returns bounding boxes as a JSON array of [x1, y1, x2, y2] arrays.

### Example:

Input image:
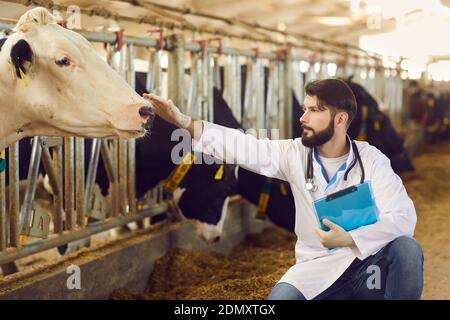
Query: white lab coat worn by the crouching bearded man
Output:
[[193, 121, 417, 299]]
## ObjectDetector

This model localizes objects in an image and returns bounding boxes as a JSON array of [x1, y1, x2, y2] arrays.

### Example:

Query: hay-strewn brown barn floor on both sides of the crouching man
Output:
[[111, 142, 450, 300]]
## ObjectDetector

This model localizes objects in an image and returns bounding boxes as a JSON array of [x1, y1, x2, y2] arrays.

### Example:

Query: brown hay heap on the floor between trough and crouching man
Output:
[[111, 228, 295, 300]]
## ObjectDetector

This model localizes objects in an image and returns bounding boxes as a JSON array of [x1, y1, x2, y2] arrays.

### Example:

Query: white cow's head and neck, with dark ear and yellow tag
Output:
[[0, 8, 154, 148]]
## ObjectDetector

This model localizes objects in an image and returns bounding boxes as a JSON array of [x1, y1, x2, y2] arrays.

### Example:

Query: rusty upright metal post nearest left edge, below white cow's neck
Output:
[[8, 142, 20, 247]]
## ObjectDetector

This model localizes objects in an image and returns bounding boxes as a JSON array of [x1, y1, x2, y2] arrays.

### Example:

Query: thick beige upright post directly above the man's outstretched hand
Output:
[[168, 34, 187, 113]]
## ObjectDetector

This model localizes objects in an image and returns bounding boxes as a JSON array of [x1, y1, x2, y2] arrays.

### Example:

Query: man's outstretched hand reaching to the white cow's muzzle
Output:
[[143, 93, 192, 129]]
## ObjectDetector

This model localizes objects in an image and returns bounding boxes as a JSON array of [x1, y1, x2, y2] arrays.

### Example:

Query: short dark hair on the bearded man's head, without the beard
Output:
[[305, 78, 356, 127]]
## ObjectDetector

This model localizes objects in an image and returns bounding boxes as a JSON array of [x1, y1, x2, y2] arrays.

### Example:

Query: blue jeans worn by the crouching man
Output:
[[268, 237, 424, 300]]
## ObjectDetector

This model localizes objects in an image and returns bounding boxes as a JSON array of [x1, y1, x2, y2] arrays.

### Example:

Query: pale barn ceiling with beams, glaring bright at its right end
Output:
[[0, 0, 450, 76]]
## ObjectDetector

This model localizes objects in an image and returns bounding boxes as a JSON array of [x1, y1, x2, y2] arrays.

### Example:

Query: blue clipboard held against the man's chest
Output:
[[314, 181, 379, 231]]
